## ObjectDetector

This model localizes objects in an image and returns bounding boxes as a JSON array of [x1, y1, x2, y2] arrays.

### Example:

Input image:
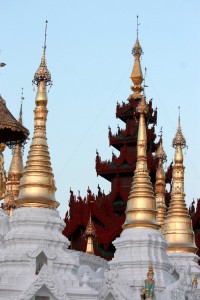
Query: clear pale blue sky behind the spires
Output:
[[0, 0, 200, 217]]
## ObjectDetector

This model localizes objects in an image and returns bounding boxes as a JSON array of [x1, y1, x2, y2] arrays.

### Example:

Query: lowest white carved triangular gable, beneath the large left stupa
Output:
[[12, 265, 69, 300]]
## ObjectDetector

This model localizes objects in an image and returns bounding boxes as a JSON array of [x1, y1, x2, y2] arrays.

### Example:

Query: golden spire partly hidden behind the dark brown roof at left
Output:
[[3, 88, 24, 215]]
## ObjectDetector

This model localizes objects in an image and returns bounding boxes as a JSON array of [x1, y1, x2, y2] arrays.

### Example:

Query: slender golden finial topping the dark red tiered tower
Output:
[[129, 16, 143, 100]]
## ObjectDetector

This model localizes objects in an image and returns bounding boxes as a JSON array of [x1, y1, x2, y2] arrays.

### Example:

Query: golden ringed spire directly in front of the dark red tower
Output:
[[123, 96, 160, 229]]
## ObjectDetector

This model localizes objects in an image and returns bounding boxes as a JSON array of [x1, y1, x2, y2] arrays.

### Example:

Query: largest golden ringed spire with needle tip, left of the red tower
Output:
[[16, 21, 59, 209]]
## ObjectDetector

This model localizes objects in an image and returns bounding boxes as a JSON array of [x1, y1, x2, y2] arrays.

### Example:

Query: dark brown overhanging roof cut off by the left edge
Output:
[[0, 96, 29, 147]]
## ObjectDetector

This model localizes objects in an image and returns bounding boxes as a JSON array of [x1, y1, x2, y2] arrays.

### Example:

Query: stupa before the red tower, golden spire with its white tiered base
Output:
[[109, 95, 173, 299]]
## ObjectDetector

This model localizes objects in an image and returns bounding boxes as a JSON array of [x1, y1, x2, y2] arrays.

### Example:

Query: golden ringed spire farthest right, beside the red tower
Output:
[[164, 109, 197, 253]]
